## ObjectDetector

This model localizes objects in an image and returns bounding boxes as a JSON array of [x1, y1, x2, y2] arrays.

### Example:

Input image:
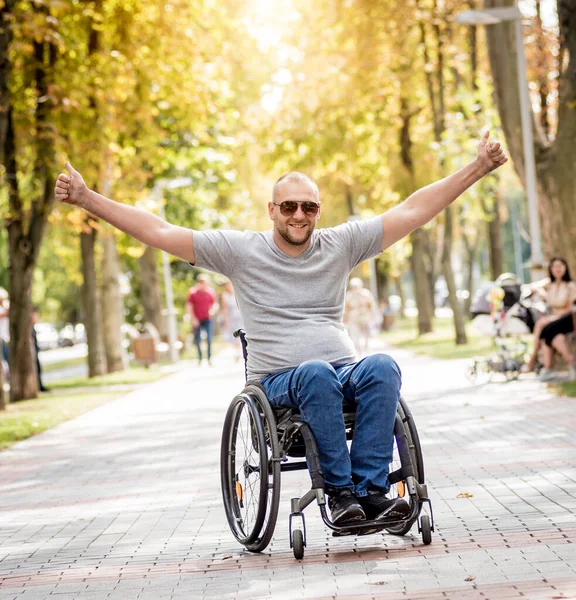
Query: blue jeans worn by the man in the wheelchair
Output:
[[261, 354, 402, 496]]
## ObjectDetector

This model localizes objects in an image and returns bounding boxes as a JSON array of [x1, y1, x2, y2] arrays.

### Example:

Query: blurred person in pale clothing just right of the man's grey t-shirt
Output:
[[344, 277, 377, 358]]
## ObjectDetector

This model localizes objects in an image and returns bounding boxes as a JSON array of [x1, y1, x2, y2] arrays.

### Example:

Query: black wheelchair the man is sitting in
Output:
[[220, 330, 434, 559]]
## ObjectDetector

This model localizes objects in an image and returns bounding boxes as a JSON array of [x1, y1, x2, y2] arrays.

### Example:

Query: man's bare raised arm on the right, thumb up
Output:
[[382, 131, 508, 250]]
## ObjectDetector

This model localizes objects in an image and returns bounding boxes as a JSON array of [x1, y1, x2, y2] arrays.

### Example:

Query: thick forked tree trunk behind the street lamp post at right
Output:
[[485, 0, 576, 271]]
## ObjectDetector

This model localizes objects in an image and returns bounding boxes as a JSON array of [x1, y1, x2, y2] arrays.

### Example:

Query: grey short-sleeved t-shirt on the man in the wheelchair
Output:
[[193, 217, 382, 379]]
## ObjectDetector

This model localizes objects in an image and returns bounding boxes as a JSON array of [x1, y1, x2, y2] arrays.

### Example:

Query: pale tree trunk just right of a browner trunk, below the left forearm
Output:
[[102, 233, 125, 373]]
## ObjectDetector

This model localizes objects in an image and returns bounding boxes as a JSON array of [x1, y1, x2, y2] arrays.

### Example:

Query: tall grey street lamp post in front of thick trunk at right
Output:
[[455, 6, 544, 281]]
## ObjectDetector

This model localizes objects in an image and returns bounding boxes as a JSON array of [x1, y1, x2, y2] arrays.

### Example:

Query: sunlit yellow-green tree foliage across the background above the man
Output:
[[0, 0, 536, 330]]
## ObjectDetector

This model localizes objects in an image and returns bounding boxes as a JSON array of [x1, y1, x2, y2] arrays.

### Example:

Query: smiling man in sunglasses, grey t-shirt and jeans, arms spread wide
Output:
[[55, 133, 507, 525]]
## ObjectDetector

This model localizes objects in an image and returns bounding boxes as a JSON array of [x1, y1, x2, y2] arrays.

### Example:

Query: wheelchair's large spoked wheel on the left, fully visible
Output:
[[220, 385, 280, 552]]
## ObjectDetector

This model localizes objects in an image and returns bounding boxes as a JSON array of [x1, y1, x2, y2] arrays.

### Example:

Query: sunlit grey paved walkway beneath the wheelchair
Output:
[[0, 342, 576, 600]]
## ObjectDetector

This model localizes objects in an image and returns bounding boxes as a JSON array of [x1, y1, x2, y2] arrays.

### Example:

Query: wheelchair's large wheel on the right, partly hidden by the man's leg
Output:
[[386, 398, 424, 535]]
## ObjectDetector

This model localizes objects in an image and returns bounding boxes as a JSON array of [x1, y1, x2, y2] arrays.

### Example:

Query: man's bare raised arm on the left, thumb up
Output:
[[54, 163, 194, 263]]
